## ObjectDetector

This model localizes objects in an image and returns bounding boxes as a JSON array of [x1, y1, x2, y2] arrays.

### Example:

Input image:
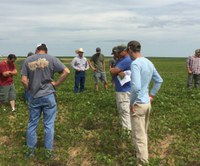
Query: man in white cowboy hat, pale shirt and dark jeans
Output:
[[71, 48, 89, 93]]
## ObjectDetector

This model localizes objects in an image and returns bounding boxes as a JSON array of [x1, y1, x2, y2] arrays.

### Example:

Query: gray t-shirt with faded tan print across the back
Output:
[[21, 54, 66, 98]]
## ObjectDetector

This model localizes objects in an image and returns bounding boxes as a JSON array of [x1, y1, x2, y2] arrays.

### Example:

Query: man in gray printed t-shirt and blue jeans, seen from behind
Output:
[[21, 44, 70, 157]]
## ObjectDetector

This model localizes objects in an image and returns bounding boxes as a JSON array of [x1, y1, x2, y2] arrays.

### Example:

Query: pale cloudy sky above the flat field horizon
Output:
[[0, 0, 200, 57]]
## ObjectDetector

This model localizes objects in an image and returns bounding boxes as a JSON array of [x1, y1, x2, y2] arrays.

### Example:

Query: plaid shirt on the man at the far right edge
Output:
[[187, 55, 200, 74]]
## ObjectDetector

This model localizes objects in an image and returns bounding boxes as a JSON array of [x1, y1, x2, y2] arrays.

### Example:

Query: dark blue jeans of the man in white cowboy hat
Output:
[[74, 71, 85, 93]]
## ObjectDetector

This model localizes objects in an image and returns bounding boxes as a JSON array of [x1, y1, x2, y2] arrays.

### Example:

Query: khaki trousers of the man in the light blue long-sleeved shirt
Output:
[[131, 103, 151, 163]]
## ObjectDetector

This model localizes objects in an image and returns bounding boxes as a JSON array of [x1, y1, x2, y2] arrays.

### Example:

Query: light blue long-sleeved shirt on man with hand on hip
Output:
[[130, 57, 163, 105]]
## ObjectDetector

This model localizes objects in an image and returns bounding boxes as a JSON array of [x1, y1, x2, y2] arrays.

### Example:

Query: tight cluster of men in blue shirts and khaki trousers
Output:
[[110, 41, 163, 165]]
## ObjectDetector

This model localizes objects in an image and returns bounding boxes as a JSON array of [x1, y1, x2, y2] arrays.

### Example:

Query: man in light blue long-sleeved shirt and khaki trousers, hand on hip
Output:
[[127, 41, 163, 166]]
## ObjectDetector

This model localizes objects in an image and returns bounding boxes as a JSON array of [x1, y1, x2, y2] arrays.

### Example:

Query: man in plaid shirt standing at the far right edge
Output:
[[187, 49, 200, 88]]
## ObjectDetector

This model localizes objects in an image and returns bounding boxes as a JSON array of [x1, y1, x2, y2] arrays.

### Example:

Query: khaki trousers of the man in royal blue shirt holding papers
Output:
[[116, 92, 131, 130]]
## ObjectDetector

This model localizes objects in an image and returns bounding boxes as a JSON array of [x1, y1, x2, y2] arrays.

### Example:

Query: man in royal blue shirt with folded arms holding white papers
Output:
[[110, 45, 132, 131]]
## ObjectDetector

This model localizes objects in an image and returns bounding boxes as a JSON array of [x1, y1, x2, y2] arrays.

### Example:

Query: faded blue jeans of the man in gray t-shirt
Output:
[[26, 93, 57, 150]]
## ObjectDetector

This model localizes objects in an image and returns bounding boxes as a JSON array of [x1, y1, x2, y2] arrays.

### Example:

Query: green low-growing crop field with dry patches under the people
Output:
[[0, 58, 200, 166]]
